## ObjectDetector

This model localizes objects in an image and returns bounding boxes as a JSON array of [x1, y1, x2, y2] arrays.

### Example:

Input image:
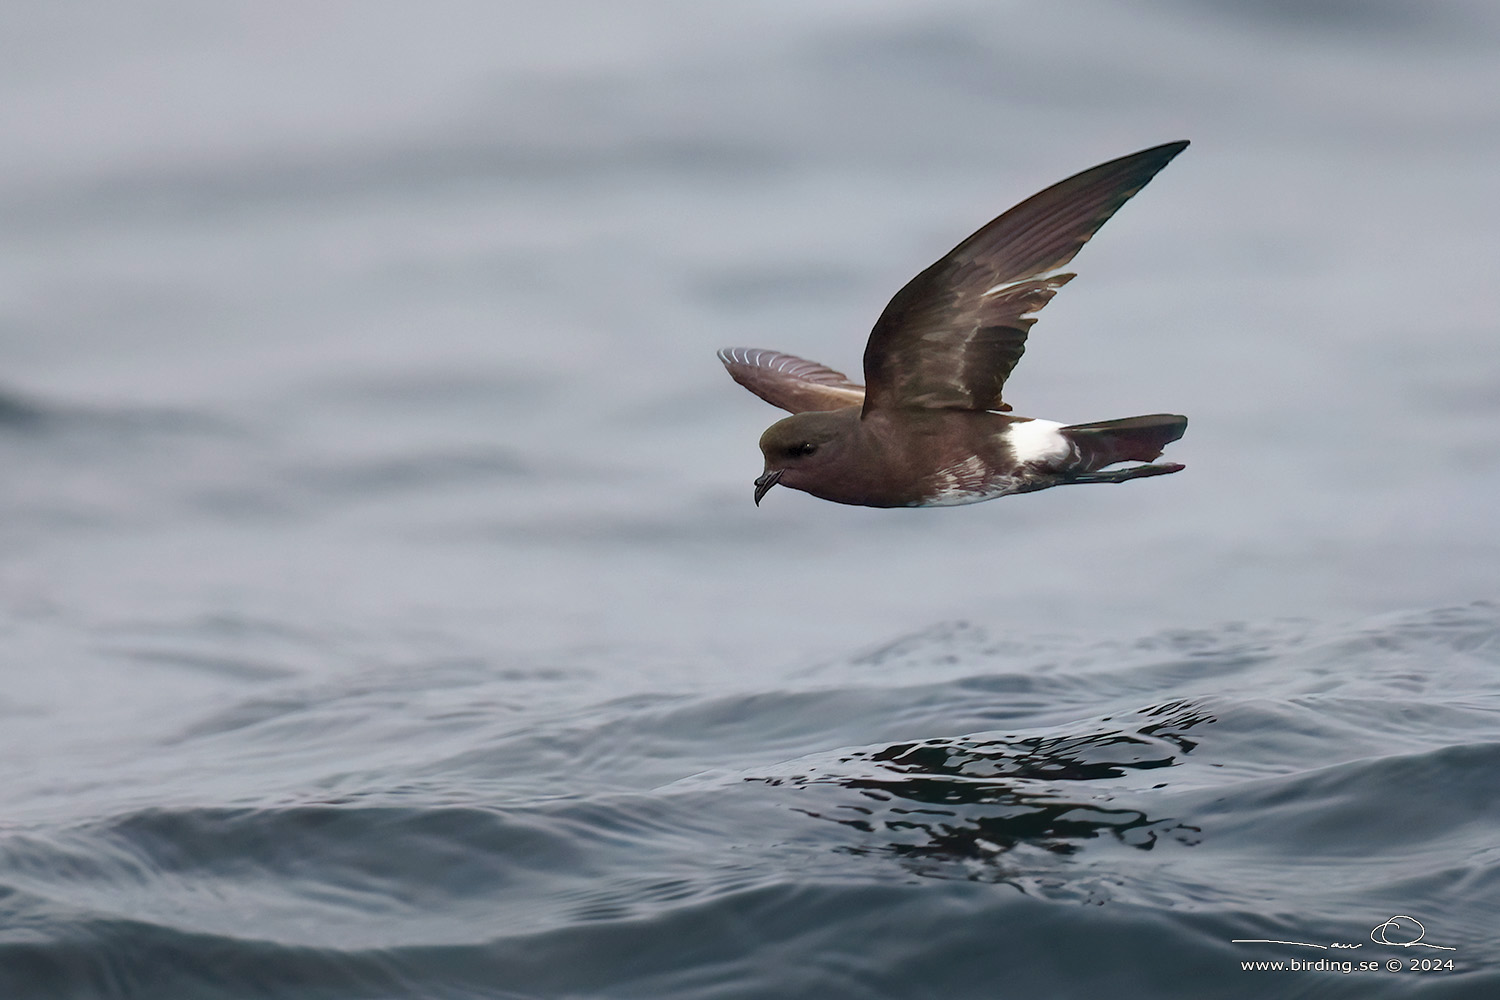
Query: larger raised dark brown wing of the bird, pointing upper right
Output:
[[864, 142, 1188, 412]]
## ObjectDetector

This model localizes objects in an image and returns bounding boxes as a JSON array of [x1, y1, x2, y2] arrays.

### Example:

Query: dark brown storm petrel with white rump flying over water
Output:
[[719, 141, 1188, 507]]
